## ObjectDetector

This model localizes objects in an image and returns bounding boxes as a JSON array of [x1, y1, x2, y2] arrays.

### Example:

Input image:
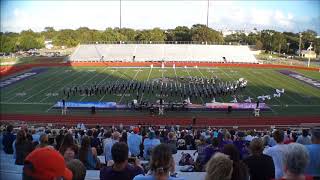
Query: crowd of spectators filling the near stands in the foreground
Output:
[[1, 125, 320, 180]]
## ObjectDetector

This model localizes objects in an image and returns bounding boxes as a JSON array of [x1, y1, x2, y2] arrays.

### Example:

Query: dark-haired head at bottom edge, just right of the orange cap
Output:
[[67, 159, 87, 180]]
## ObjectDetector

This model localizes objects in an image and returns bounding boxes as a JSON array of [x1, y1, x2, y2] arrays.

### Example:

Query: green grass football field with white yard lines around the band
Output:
[[0, 67, 320, 116]]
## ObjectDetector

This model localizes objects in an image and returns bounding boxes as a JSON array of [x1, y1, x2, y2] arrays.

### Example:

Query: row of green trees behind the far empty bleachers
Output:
[[0, 24, 320, 54]]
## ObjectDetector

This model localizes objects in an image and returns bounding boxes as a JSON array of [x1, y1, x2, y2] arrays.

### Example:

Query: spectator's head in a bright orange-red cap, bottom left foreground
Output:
[[22, 147, 72, 180]]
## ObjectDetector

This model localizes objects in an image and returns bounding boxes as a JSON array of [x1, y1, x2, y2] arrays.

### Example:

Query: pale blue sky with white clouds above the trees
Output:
[[1, 0, 320, 34]]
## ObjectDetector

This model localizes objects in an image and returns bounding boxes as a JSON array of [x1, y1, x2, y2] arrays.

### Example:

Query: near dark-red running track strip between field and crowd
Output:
[[0, 114, 320, 127]]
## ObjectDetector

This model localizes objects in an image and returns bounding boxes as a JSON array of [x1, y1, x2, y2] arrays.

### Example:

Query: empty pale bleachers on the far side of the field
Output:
[[70, 44, 257, 63]]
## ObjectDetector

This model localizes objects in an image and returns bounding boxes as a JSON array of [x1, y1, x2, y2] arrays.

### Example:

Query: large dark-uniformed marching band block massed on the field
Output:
[[63, 77, 248, 99]]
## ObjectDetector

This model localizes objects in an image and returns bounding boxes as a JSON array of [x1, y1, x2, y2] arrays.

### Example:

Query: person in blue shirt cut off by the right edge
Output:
[[305, 128, 320, 179]]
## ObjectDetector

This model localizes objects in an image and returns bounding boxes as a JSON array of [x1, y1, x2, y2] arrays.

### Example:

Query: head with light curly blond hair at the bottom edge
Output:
[[205, 153, 233, 180]]
